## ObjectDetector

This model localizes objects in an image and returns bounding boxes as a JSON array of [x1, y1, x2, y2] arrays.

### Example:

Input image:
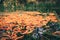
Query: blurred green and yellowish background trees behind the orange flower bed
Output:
[[0, 0, 60, 15]]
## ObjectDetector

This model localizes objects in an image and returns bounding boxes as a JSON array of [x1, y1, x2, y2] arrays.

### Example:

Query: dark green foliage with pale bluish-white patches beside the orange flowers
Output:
[[24, 21, 60, 40]]
